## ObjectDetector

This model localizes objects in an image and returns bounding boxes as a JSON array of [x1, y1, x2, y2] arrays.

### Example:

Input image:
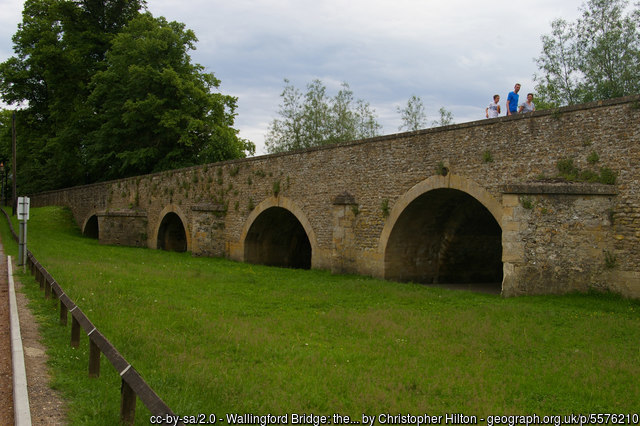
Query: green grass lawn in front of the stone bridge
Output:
[[0, 208, 640, 424]]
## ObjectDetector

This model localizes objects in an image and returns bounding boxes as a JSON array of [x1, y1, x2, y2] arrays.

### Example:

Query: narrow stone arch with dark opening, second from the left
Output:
[[153, 204, 191, 252]]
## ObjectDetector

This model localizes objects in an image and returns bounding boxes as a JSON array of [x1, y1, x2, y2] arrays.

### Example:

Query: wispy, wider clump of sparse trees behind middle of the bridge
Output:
[[265, 79, 381, 153]]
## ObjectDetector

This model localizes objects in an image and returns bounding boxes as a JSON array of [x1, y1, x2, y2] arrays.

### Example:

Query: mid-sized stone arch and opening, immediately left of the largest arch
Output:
[[240, 196, 318, 269]]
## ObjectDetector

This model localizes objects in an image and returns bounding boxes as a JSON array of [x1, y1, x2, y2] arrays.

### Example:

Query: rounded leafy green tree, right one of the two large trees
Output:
[[88, 14, 254, 180]]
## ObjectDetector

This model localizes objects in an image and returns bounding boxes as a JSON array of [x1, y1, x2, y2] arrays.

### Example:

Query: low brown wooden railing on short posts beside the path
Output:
[[2, 210, 176, 424]]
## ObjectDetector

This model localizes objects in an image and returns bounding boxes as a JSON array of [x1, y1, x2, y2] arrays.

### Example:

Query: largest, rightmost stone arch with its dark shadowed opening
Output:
[[379, 175, 503, 292]]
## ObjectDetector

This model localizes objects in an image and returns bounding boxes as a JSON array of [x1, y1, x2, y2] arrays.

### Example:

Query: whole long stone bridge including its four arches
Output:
[[32, 96, 640, 297]]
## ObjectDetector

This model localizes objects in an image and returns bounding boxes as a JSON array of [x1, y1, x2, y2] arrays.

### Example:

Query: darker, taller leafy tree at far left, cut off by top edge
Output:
[[0, 0, 143, 192]]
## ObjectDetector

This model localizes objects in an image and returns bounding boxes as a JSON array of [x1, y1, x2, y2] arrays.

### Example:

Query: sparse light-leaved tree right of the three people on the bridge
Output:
[[534, 0, 640, 106]]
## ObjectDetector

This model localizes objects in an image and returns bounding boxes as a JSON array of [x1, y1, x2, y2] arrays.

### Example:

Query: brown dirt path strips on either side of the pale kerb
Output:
[[0, 241, 68, 425]]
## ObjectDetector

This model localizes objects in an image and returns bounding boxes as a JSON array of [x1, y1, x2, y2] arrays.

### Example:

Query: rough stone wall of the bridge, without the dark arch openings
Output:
[[32, 96, 640, 296]]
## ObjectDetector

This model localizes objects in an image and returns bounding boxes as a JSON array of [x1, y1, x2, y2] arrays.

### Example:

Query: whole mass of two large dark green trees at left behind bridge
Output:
[[0, 0, 254, 192]]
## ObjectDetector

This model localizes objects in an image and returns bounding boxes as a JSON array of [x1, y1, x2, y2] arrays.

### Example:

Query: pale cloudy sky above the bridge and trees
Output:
[[0, 0, 583, 154]]
